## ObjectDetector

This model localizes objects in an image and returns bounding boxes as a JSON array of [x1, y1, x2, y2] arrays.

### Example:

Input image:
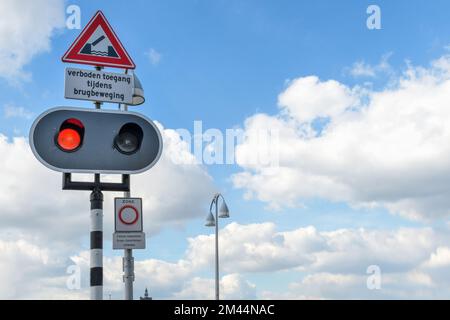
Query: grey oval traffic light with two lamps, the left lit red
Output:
[[30, 107, 162, 174]]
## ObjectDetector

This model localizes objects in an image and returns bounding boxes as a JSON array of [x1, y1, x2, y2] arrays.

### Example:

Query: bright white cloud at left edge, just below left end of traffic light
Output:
[[0, 135, 89, 245]]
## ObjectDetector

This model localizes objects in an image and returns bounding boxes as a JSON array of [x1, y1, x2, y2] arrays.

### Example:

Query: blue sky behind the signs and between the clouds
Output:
[[0, 0, 450, 298]]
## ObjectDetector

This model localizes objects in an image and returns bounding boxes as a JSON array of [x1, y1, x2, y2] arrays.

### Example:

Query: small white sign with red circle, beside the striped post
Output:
[[114, 198, 142, 232]]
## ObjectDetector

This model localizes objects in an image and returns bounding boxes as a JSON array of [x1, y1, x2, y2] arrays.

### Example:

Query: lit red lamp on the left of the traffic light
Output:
[[55, 118, 84, 152]]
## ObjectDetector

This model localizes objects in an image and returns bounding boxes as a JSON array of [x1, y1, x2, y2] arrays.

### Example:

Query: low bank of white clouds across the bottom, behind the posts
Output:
[[0, 222, 450, 299]]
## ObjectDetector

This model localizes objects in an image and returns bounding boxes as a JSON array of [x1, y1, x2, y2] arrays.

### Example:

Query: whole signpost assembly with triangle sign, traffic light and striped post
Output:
[[30, 11, 162, 300]]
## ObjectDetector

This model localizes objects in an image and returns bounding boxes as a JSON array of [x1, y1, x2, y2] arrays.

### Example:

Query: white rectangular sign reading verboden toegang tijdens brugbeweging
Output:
[[64, 68, 134, 104]]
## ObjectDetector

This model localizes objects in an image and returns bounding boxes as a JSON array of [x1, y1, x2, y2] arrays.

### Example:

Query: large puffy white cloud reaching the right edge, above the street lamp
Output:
[[232, 56, 450, 219]]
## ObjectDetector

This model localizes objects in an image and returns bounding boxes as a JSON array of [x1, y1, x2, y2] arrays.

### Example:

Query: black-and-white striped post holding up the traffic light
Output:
[[90, 181, 103, 300]]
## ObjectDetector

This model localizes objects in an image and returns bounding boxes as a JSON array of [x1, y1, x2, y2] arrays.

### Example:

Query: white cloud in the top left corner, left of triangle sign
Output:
[[0, 0, 64, 83]]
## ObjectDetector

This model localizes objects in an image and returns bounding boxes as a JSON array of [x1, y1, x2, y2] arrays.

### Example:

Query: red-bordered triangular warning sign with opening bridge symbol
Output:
[[62, 11, 136, 69]]
